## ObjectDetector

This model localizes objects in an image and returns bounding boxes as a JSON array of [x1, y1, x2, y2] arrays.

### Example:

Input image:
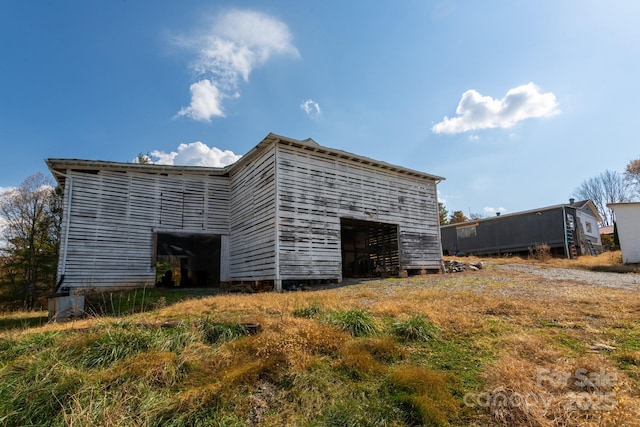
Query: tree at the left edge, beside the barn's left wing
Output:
[[0, 173, 61, 309]]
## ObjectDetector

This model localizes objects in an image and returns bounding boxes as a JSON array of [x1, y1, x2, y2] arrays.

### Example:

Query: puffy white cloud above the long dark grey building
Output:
[[431, 83, 560, 133]]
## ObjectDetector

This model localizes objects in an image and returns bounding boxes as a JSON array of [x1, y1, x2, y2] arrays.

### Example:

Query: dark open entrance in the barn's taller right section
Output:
[[340, 218, 400, 278]]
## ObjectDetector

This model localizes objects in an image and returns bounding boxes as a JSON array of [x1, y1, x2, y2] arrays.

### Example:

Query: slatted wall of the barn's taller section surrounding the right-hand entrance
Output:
[[278, 146, 441, 280]]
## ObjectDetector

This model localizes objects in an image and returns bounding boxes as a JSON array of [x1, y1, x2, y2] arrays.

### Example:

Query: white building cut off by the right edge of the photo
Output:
[[607, 202, 640, 264]]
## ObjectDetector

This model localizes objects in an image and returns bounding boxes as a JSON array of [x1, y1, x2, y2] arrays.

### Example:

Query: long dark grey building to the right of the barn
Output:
[[441, 199, 602, 258]]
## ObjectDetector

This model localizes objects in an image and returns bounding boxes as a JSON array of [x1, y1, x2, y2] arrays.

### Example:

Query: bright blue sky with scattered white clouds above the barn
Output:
[[0, 0, 640, 215]]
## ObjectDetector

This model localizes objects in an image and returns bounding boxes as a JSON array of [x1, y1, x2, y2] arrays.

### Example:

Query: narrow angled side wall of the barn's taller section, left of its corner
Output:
[[229, 146, 276, 280]]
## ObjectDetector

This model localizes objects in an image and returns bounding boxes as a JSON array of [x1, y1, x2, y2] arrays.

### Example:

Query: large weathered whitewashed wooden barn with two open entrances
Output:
[[47, 134, 443, 318]]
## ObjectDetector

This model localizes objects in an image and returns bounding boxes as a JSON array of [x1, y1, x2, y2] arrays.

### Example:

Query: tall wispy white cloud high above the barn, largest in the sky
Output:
[[176, 10, 299, 122]]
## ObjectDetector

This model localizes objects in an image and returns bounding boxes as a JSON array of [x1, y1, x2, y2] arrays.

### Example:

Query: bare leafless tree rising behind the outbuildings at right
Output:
[[573, 170, 629, 227]]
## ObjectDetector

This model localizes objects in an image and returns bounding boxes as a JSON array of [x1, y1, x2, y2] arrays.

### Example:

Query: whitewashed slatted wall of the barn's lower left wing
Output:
[[58, 171, 229, 288]]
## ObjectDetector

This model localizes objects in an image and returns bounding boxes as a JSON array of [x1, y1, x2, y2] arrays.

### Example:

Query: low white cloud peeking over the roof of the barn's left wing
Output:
[[149, 141, 242, 168]]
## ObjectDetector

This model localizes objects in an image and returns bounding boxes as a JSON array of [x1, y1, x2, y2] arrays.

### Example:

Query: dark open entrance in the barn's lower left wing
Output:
[[155, 233, 220, 287]]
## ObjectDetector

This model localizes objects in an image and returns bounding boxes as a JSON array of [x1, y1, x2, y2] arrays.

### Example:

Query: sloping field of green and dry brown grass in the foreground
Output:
[[0, 254, 640, 426]]
